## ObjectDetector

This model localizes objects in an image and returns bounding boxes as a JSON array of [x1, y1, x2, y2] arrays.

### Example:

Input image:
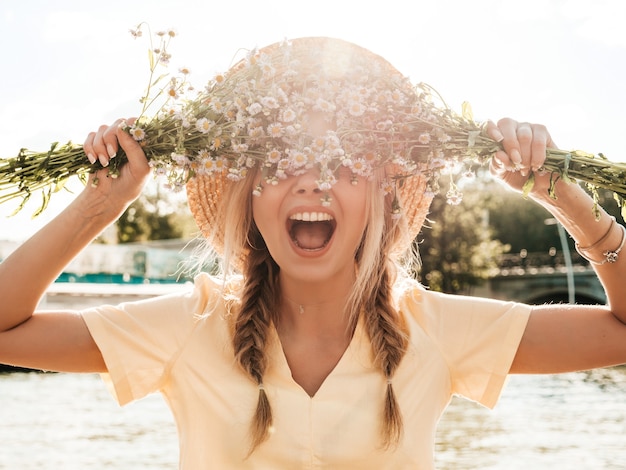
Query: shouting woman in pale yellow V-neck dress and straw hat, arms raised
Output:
[[0, 38, 626, 469]]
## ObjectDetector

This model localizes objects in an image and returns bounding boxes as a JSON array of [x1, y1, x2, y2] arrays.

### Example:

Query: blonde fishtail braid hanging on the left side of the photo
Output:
[[233, 230, 277, 453]]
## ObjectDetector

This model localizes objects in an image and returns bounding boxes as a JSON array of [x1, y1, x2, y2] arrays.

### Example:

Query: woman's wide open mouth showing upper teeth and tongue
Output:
[[287, 212, 337, 251]]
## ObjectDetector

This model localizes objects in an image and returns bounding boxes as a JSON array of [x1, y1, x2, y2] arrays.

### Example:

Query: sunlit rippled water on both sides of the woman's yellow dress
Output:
[[0, 368, 626, 470]]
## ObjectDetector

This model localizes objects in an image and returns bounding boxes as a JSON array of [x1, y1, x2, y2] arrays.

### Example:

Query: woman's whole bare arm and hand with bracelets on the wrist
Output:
[[490, 119, 626, 373]]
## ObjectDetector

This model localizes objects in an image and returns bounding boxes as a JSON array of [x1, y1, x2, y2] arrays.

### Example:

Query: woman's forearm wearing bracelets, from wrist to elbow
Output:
[[534, 183, 626, 323]]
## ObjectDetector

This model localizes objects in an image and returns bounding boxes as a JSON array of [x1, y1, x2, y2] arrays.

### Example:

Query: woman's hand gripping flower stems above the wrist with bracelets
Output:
[[487, 118, 557, 198]]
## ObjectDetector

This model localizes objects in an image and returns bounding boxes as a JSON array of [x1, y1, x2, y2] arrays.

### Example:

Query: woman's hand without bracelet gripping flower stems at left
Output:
[[83, 119, 150, 212]]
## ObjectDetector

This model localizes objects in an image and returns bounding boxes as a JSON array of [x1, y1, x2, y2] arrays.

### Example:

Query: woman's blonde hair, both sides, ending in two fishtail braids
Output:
[[206, 170, 411, 453]]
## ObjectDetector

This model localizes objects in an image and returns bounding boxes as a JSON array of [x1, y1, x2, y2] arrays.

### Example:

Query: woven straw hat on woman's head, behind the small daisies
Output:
[[187, 37, 434, 260]]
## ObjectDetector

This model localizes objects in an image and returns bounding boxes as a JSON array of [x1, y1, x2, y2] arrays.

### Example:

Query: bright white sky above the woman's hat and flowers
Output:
[[0, 0, 626, 241]]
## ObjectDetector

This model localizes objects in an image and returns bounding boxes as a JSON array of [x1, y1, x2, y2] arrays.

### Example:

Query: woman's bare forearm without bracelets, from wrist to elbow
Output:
[[0, 190, 123, 331]]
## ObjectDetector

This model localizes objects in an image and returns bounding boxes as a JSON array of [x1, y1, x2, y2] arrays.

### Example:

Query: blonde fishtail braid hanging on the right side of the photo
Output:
[[364, 255, 408, 448]]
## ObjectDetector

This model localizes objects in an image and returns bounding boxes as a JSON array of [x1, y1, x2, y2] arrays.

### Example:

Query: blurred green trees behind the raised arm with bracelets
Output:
[[418, 174, 623, 294]]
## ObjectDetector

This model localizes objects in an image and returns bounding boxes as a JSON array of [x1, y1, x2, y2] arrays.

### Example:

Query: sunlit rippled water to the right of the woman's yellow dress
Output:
[[436, 367, 626, 470]]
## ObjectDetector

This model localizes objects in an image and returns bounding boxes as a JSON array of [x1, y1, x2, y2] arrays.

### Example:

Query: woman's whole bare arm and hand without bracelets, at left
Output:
[[0, 120, 149, 371]]
